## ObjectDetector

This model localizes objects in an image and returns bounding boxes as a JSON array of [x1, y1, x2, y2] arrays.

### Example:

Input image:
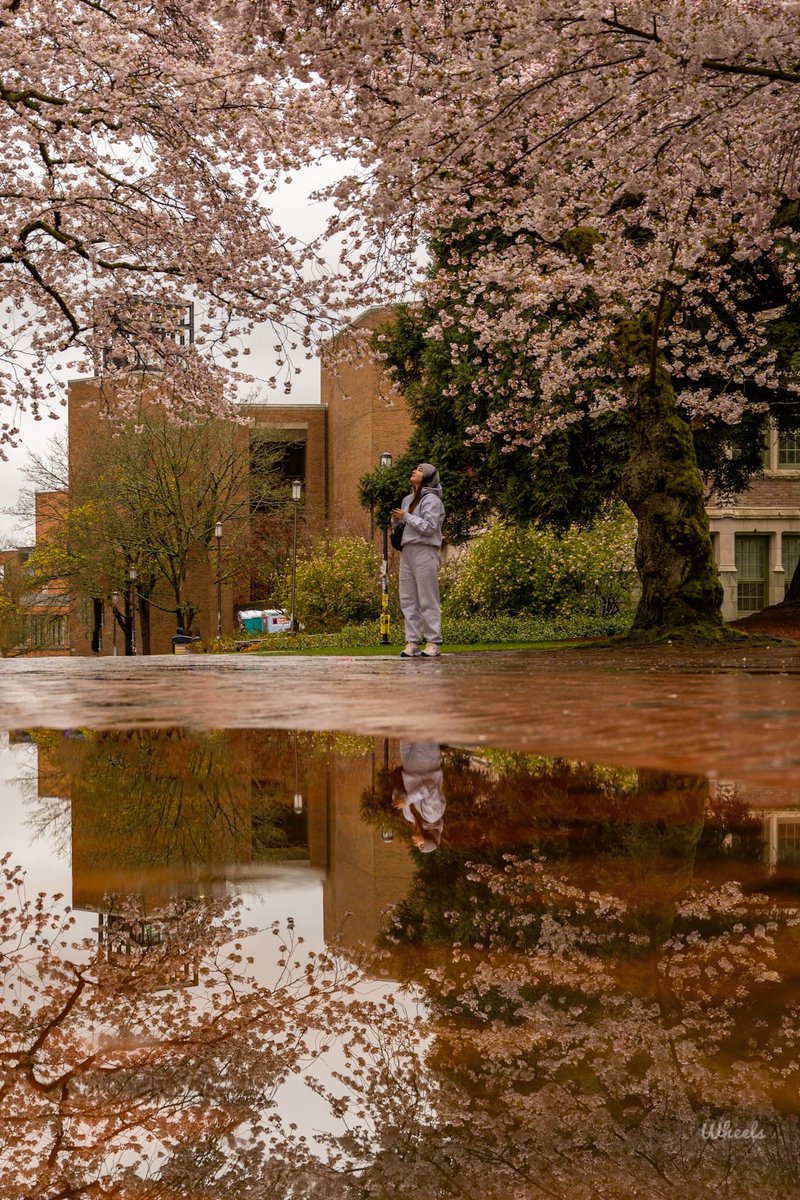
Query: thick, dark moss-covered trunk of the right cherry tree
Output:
[[621, 343, 722, 635]]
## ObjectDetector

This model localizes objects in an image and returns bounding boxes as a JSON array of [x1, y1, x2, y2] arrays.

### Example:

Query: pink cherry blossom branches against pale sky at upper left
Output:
[[0, 0, 331, 452]]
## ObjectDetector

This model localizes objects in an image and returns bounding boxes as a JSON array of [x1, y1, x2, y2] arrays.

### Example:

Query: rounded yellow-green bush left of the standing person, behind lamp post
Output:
[[281, 536, 380, 631]]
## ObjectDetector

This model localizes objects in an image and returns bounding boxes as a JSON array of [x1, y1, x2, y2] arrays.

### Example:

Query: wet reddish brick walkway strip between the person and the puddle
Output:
[[0, 647, 800, 787]]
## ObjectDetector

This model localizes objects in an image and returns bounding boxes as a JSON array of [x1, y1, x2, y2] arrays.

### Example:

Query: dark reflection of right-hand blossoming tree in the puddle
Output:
[[341, 755, 800, 1200]]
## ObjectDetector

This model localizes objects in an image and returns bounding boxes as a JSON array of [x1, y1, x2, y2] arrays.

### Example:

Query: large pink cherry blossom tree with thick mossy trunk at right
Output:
[[286, 0, 800, 631]]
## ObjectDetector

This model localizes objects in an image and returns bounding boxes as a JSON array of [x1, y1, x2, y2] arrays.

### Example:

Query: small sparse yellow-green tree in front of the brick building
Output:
[[26, 406, 288, 654]]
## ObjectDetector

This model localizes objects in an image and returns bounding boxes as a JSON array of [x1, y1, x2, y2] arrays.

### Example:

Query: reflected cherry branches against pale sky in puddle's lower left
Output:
[[0, 860, 355, 1200]]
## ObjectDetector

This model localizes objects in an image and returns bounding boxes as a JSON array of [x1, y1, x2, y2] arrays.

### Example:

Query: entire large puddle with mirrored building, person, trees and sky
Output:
[[0, 730, 800, 1200]]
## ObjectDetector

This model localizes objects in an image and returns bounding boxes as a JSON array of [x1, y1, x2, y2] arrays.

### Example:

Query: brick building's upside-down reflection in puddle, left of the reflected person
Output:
[[26, 730, 413, 946]]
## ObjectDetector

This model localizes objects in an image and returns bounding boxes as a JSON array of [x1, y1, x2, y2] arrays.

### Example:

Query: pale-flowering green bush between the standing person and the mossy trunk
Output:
[[444, 508, 636, 617]]
